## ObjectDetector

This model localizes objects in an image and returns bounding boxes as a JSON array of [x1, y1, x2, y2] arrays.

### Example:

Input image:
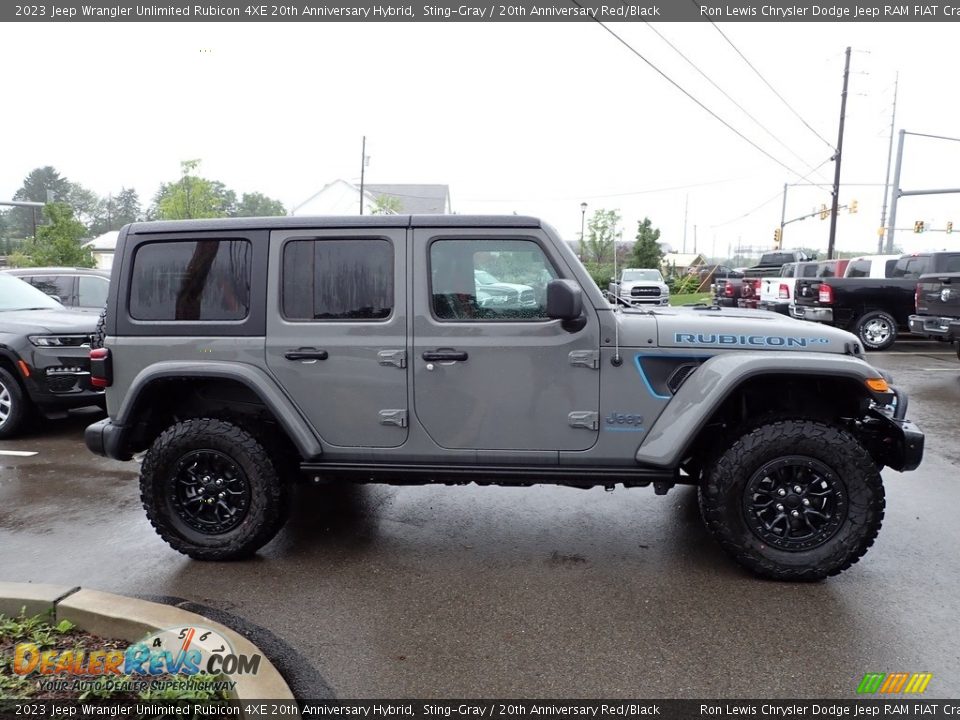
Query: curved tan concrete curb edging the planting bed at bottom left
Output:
[[0, 582, 296, 701]]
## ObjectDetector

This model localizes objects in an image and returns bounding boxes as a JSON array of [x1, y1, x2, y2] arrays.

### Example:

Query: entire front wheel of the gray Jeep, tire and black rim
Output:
[[699, 420, 884, 581]]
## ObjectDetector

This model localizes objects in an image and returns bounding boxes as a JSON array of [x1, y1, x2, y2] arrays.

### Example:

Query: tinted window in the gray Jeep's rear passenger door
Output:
[[280, 239, 393, 320]]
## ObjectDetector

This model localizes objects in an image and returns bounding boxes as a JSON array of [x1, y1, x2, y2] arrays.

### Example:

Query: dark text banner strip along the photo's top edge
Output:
[[0, 0, 960, 23]]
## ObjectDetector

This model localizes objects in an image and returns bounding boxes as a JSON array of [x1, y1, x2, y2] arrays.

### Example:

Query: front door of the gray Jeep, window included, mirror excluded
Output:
[[410, 228, 600, 451]]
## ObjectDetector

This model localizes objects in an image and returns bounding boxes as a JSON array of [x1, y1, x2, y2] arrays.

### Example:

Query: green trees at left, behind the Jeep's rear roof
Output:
[[0, 160, 286, 267]]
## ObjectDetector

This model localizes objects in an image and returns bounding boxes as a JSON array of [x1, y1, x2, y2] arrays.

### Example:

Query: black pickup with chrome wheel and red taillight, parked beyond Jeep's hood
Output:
[[793, 252, 960, 350]]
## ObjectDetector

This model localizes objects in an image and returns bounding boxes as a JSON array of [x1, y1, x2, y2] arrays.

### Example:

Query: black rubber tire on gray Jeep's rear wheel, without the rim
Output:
[[140, 418, 290, 560]]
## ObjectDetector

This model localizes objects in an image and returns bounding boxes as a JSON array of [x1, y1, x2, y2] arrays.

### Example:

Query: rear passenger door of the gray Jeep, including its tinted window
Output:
[[266, 227, 408, 448]]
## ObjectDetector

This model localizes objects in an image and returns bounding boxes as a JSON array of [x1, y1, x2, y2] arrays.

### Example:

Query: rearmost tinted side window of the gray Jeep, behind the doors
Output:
[[130, 240, 252, 322]]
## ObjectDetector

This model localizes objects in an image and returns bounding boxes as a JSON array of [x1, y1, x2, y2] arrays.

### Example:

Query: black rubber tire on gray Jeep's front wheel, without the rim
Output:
[[699, 420, 884, 582]]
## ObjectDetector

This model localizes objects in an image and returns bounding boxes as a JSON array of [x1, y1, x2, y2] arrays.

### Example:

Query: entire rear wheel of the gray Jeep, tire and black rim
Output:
[[140, 418, 289, 560]]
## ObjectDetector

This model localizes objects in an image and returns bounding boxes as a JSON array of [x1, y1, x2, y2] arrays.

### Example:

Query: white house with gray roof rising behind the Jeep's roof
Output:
[[290, 180, 452, 215]]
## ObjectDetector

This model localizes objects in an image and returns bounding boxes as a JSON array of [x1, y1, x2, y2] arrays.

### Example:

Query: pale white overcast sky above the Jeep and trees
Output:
[[0, 22, 960, 256]]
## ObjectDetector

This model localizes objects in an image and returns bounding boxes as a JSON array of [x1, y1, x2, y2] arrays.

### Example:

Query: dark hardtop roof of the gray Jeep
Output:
[[127, 215, 542, 235]]
